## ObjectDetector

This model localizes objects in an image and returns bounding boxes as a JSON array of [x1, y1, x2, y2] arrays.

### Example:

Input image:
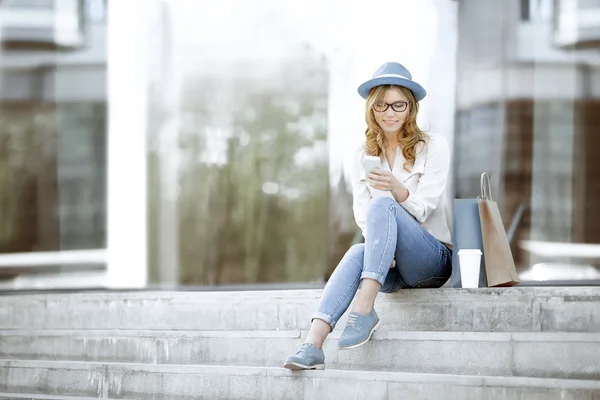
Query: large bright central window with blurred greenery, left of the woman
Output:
[[148, 1, 330, 285]]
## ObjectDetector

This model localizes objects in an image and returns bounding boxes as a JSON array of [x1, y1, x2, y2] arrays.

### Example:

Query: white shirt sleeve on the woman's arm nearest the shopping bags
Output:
[[400, 135, 450, 223]]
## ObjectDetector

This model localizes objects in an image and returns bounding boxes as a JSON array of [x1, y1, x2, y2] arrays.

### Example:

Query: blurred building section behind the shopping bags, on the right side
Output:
[[454, 0, 600, 281]]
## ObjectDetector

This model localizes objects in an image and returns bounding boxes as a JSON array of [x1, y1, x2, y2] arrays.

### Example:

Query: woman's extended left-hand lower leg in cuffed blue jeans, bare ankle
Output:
[[306, 243, 365, 348]]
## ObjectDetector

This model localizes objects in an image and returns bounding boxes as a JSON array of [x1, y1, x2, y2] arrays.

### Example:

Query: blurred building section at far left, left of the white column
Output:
[[0, 0, 107, 287]]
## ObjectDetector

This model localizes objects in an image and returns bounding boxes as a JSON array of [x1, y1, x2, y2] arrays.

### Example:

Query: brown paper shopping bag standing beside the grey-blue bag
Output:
[[478, 172, 520, 287]]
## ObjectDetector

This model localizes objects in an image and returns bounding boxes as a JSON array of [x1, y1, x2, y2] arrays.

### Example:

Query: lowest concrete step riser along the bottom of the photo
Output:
[[0, 361, 600, 400]]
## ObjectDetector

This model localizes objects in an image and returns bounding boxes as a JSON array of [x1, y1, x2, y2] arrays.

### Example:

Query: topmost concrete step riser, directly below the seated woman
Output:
[[0, 287, 600, 332]]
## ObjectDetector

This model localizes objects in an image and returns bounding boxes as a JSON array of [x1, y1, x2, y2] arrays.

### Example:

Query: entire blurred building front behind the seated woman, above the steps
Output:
[[0, 0, 600, 289]]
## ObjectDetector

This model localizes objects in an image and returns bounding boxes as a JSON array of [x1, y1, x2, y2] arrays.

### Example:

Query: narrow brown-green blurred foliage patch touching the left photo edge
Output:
[[0, 104, 59, 253]]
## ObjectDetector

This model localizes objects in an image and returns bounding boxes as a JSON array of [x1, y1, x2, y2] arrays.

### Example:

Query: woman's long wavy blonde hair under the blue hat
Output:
[[365, 85, 427, 171]]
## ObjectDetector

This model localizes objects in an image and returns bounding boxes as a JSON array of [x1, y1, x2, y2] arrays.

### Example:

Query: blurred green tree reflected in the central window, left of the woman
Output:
[[179, 51, 329, 284]]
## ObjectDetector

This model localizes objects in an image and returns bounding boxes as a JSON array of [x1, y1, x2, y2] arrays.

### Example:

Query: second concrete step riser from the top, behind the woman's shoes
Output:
[[0, 330, 600, 380]]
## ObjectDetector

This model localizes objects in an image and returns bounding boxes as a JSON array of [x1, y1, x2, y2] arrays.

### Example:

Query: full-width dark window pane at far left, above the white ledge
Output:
[[0, 103, 106, 252]]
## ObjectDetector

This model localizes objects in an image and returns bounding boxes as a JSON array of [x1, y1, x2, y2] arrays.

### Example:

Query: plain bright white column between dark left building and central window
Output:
[[107, 0, 149, 288]]
